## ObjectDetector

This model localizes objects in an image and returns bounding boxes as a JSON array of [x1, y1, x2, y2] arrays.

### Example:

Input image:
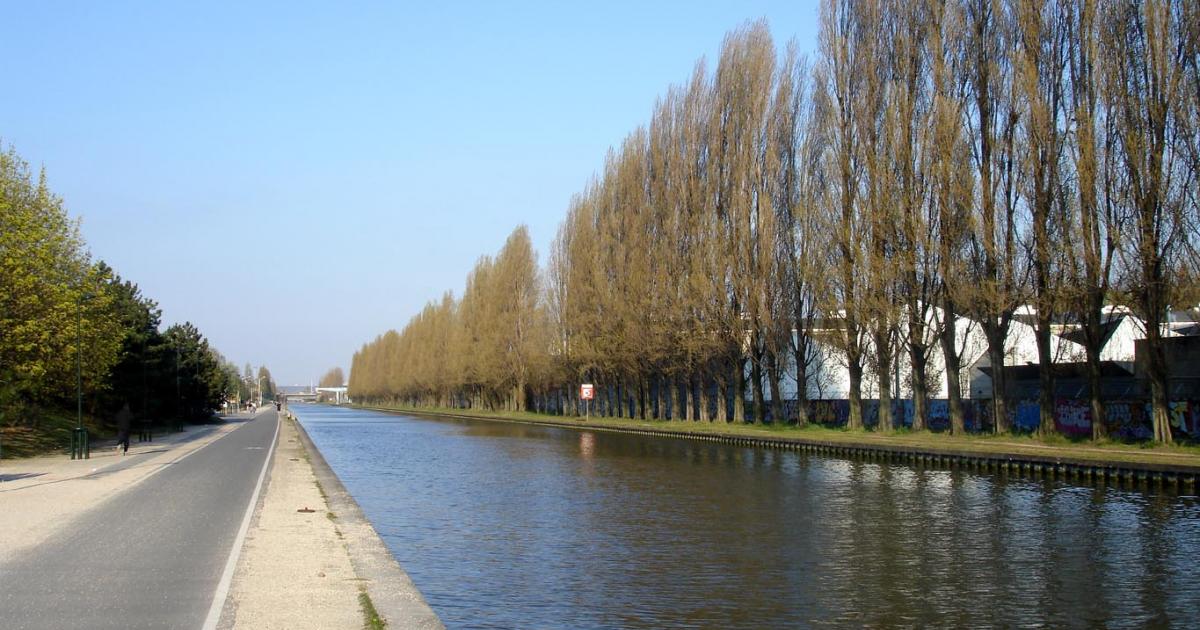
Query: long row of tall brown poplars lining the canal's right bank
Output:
[[350, 0, 1200, 442]]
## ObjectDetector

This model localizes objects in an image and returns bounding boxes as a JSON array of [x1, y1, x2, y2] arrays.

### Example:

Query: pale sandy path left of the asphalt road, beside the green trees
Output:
[[0, 416, 248, 554]]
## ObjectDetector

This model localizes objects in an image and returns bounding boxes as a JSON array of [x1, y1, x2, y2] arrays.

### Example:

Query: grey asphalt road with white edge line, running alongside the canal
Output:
[[0, 409, 277, 630]]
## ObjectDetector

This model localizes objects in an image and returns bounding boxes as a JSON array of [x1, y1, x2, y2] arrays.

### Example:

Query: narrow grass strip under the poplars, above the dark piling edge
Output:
[[364, 406, 1200, 468]]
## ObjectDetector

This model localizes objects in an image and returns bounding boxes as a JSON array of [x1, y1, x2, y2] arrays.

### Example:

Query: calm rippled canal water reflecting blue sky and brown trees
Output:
[[292, 404, 1200, 628]]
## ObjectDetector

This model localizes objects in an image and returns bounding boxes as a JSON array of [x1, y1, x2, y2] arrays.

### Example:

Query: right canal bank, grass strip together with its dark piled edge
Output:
[[364, 407, 1200, 493]]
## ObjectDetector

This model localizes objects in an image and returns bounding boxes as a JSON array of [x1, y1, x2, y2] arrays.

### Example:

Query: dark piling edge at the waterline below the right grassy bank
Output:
[[365, 407, 1200, 494]]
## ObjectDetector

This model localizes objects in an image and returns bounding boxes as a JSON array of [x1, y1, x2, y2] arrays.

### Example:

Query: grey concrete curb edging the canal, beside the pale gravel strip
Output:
[[291, 420, 445, 629]]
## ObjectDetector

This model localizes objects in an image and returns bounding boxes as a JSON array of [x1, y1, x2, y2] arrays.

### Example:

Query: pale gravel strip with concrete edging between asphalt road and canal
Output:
[[218, 412, 443, 630]]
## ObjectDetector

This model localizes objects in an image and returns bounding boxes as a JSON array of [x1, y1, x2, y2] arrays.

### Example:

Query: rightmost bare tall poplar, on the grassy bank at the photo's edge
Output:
[[1103, 0, 1196, 443]]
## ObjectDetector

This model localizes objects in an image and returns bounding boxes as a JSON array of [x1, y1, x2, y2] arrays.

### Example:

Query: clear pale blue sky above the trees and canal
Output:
[[0, 0, 818, 385]]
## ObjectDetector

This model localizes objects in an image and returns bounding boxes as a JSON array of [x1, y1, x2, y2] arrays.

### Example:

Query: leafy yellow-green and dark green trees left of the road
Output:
[[0, 148, 260, 431]]
